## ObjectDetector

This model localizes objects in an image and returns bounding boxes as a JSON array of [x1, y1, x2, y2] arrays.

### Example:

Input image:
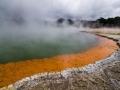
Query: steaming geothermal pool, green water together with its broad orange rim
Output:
[[0, 27, 118, 87]]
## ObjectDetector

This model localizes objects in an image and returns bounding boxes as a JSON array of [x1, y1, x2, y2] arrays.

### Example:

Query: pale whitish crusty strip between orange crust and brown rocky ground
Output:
[[0, 30, 120, 90]]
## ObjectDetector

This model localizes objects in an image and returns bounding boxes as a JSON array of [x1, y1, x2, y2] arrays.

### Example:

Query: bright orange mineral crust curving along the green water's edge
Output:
[[0, 37, 118, 87]]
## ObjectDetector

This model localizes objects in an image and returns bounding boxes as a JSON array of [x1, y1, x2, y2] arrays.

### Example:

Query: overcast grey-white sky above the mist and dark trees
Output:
[[0, 0, 120, 20]]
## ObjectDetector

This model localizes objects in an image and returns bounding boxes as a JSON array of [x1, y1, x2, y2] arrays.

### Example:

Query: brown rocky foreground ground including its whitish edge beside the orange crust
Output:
[[0, 32, 120, 90]]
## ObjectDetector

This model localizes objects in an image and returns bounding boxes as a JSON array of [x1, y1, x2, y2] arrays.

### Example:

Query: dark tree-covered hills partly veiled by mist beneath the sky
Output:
[[56, 16, 120, 28]]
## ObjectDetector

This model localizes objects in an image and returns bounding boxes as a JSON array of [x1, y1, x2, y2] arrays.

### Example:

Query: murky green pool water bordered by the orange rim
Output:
[[0, 29, 98, 63]]
